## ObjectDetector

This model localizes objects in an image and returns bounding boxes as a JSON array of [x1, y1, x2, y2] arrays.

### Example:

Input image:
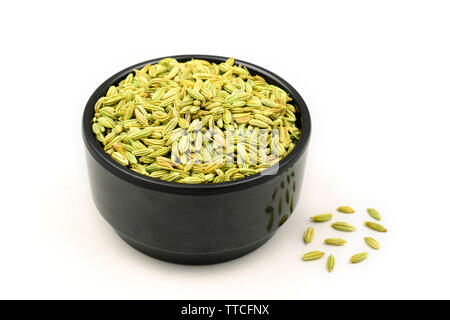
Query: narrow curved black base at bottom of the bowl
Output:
[[116, 230, 273, 265]]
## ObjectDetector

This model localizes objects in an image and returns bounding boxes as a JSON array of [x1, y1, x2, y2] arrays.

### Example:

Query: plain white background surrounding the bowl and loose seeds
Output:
[[0, 0, 450, 299]]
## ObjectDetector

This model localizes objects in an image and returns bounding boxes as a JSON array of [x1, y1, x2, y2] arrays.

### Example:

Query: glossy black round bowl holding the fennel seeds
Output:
[[82, 55, 311, 264]]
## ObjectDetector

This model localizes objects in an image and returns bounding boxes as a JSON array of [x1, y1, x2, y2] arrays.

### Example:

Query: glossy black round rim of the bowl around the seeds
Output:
[[82, 54, 311, 195]]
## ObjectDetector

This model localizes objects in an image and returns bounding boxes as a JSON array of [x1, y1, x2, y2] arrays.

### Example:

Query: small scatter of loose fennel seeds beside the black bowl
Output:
[[302, 206, 387, 272]]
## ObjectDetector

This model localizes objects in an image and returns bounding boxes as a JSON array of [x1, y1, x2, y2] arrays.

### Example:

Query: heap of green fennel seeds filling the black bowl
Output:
[[92, 58, 301, 184]]
